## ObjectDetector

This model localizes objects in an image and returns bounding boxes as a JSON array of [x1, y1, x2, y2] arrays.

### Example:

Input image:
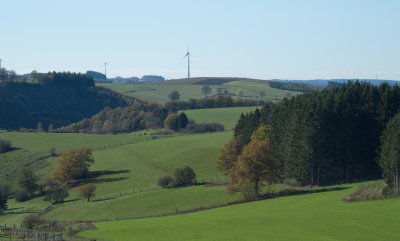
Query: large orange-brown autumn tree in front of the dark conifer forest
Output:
[[228, 140, 282, 198]]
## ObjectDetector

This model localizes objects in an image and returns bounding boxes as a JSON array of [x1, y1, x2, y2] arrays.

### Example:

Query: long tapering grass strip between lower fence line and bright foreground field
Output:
[[45, 186, 239, 221]]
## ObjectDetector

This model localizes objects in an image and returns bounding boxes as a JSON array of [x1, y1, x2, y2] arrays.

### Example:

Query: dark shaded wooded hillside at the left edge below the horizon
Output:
[[0, 77, 133, 130]]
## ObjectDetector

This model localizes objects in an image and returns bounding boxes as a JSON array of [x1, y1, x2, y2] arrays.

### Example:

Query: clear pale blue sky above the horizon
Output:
[[0, 0, 400, 80]]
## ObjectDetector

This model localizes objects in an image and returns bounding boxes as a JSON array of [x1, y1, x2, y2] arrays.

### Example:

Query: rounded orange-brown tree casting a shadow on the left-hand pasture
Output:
[[51, 147, 94, 186]]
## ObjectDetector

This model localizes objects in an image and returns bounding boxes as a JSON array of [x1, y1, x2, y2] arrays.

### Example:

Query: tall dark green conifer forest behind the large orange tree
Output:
[[234, 82, 400, 185]]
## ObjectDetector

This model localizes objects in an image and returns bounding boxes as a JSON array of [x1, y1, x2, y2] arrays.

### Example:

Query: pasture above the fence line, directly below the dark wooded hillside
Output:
[[0, 131, 155, 184]]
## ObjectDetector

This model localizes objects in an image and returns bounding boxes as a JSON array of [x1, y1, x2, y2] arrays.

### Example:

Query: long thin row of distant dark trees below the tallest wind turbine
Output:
[[164, 95, 265, 111]]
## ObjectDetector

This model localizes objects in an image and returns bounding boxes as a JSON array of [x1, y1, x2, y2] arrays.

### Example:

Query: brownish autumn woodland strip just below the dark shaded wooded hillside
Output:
[[56, 102, 168, 134]]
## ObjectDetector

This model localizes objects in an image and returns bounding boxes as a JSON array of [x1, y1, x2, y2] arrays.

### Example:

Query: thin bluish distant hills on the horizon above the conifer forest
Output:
[[273, 79, 400, 88]]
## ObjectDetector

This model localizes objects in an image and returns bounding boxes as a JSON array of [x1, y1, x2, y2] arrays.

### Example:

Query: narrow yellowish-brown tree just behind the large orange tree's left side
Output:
[[217, 138, 242, 175]]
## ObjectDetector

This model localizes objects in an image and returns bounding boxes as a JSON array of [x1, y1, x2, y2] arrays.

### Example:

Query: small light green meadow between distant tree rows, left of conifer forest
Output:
[[181, 107, 257, 130]]
